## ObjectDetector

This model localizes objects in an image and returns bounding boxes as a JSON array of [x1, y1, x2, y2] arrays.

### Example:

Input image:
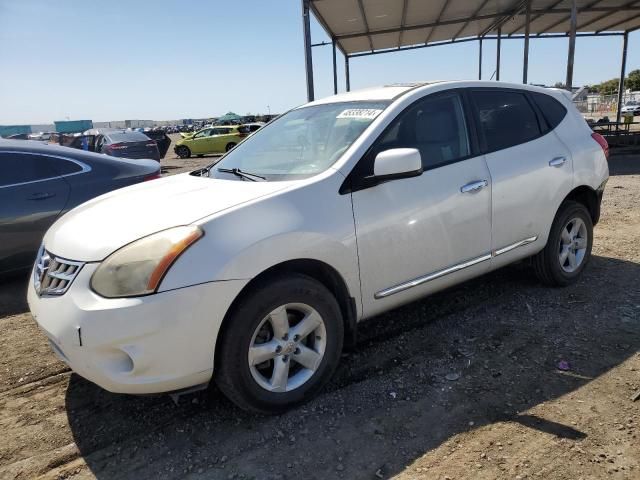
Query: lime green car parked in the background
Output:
[[173, 125, 249, 158]]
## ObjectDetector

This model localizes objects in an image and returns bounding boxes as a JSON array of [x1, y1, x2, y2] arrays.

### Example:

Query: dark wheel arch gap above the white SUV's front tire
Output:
[[214, 258, 358, 365]]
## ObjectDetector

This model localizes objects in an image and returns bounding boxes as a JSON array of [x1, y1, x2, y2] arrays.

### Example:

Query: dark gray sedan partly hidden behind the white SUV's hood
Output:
[[0, 140, 160, 274]]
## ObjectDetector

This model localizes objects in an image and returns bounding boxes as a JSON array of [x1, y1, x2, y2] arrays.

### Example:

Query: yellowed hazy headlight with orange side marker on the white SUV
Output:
[[91, 226, 204, 298]]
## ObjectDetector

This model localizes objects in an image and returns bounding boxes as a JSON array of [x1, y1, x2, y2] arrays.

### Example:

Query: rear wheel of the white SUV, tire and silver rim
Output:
[[533, 201, 593, 286]]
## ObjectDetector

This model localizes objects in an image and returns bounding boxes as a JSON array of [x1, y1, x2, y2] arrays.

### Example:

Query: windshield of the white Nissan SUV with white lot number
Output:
[[209, 101, 390, 181]]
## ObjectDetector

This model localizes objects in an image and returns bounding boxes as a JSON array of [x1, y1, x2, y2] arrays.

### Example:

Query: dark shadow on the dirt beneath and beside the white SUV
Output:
[[66, 257, 640, 479]]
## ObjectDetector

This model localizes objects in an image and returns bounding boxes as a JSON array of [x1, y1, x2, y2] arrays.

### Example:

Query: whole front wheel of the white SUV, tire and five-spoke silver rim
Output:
[[214, 275, 344, 413]]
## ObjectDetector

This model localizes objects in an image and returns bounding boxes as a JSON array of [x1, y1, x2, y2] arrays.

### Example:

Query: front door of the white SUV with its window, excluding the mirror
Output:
[[352, 93, 491, 316]]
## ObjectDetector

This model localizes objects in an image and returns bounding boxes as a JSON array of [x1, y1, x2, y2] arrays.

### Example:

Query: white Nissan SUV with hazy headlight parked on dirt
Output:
[[28, 81, 608, 412]]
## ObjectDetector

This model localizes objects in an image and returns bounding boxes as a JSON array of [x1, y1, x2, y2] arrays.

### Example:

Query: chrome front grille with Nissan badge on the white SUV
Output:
[[33, 245, 84, 296]]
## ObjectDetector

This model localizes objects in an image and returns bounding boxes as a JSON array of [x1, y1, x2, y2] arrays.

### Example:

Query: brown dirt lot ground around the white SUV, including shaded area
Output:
[[0, 152, 640, 480]]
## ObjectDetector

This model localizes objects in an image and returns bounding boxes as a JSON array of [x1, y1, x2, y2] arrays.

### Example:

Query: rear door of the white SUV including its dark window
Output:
[[471, 88, 573, 267]]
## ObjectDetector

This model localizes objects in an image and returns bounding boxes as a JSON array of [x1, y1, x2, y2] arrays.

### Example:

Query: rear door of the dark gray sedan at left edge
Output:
[[0, 151, 69, 272]]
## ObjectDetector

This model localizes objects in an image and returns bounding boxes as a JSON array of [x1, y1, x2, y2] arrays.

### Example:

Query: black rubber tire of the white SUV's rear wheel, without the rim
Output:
[[532, 200, 593, 287]]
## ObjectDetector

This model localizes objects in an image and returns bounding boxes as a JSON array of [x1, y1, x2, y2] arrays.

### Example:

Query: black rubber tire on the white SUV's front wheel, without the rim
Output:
[[214, 274, 344, 414]]
